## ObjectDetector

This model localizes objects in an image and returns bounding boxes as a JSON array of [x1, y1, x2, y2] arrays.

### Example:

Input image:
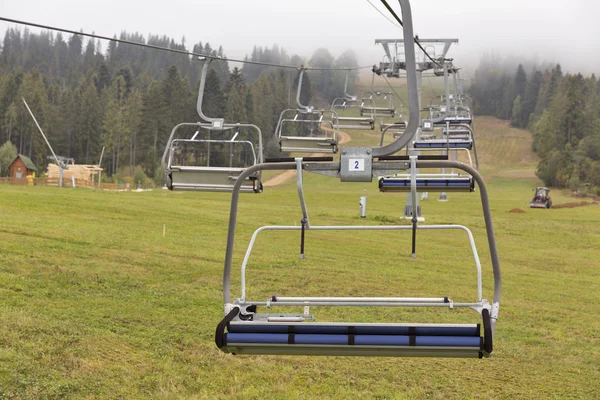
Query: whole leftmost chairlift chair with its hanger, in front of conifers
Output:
[[162, 59, 263, 193]]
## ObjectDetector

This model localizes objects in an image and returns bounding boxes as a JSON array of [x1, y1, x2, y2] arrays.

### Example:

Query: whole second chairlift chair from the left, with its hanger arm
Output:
[[275, 68, 340, 153]]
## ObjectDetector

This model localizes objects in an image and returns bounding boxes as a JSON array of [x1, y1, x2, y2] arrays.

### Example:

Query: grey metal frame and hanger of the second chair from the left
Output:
[[275, 67, 340, 153]]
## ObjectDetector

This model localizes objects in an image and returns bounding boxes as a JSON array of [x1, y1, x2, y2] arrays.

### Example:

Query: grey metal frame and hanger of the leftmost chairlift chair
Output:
[[161, 58, 264, 193]]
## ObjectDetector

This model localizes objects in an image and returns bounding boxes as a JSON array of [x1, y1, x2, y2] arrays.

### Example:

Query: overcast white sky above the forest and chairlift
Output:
[[0, 0, 600, 73]]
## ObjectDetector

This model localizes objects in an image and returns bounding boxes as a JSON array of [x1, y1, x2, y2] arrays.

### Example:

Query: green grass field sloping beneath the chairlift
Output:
[[0, 118, 600, 399]]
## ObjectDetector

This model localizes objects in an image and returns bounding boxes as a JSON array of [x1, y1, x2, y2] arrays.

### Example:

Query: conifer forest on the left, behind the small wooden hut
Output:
[[0, 28, 357, 184]]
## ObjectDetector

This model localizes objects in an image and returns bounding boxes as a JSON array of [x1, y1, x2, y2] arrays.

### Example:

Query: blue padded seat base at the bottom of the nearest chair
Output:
[[215, 309, 493, 358]]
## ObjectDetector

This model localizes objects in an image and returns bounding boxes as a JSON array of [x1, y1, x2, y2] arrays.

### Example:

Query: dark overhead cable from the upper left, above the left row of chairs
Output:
[[0, 17, 373, 71]]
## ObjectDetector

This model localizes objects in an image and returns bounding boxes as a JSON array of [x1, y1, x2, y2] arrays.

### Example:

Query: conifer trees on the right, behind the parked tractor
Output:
[[469, 58, 600, 189]]
